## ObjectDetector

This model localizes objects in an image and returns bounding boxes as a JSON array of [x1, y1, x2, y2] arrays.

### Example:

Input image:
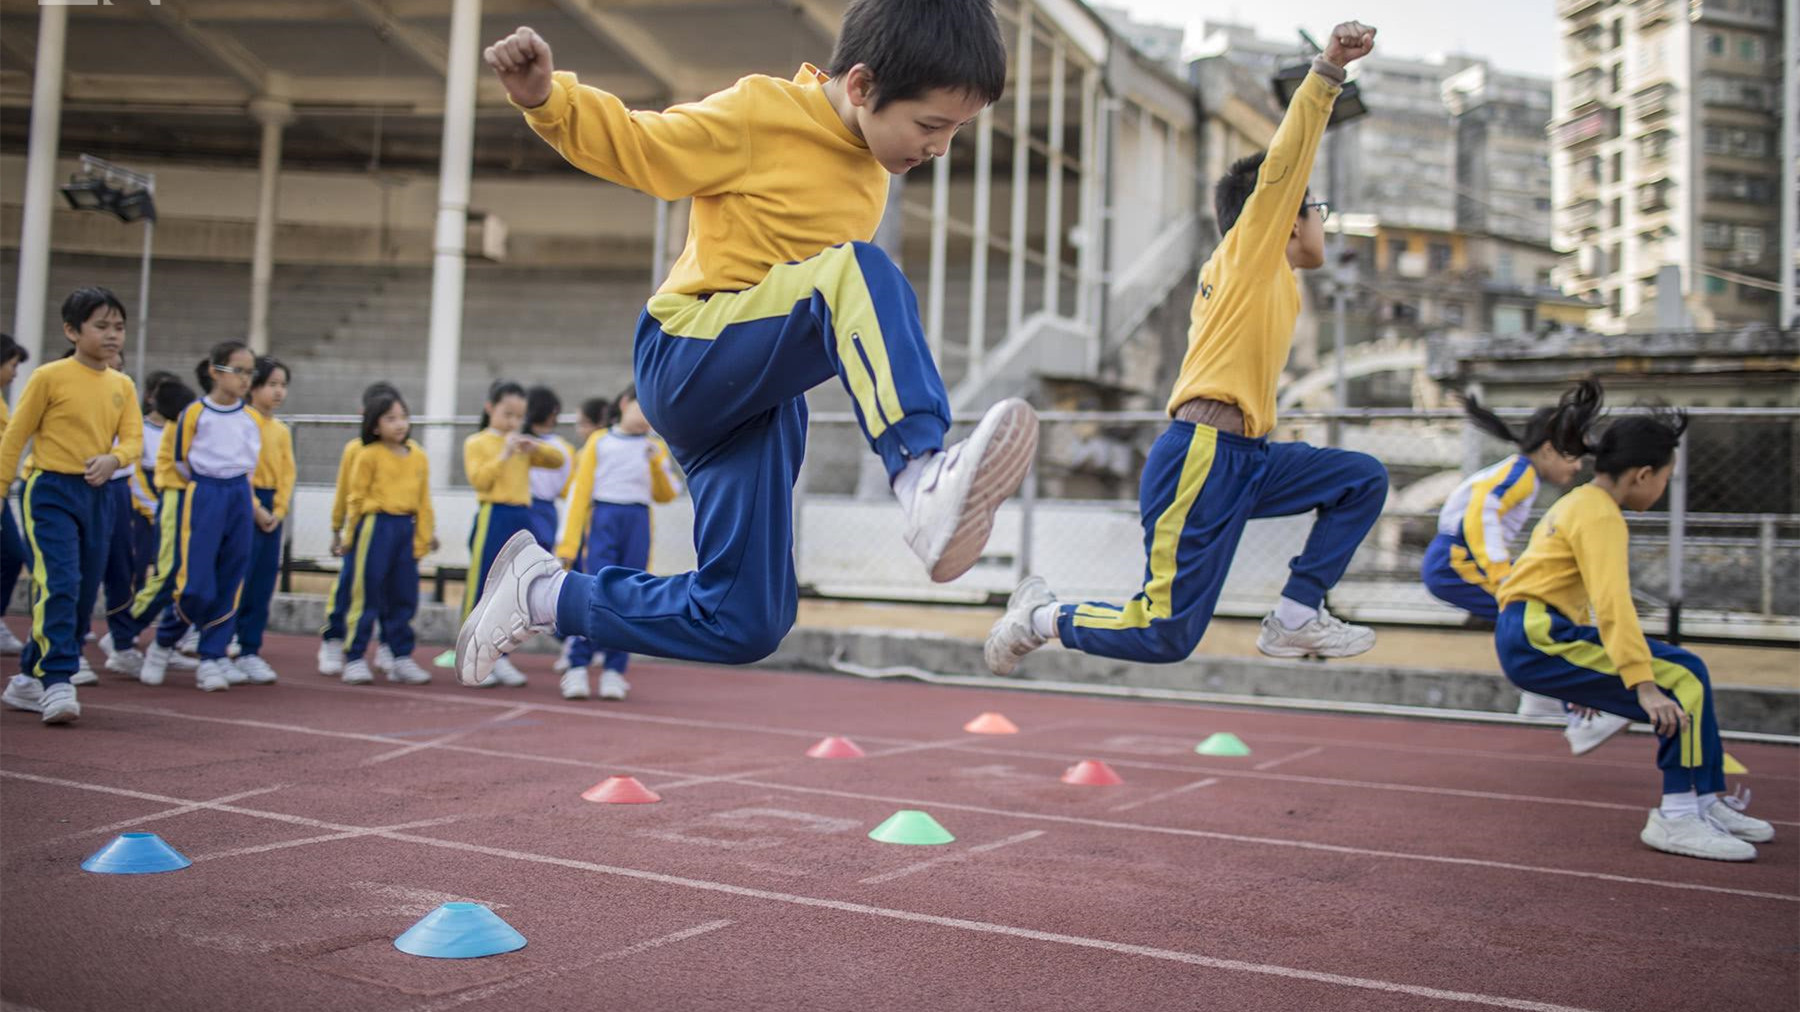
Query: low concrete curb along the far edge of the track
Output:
[[270, 594, 1800, 736]]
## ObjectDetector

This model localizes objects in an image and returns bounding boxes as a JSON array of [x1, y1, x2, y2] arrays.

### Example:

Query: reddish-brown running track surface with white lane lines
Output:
[[0, 626, 1800, 1012]]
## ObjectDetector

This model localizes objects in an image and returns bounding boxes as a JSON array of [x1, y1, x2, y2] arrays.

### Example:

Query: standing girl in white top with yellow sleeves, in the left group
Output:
[[113, 340, 262, 691]]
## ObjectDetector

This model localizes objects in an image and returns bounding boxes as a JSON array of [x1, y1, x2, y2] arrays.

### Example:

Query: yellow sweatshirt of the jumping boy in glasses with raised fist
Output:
[[1168, 72, 1341, 436]]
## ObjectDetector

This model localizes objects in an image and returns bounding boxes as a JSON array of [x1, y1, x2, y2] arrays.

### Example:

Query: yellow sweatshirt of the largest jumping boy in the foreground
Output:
[[524, 63, 885, 295]]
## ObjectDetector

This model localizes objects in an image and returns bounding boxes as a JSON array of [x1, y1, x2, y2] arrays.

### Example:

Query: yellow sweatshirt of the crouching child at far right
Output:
[[1499, 484, 1651, 688]]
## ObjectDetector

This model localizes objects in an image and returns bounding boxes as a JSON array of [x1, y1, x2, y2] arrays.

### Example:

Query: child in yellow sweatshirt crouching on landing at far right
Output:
[[1494, 411, 1775, 861]]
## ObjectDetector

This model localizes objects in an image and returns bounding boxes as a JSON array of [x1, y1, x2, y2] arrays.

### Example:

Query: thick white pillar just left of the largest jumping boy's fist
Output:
[[425, 0, 481, 486]]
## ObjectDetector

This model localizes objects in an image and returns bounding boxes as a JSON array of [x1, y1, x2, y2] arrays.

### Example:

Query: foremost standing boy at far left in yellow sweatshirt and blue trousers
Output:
[[0, 288, 144, 724]]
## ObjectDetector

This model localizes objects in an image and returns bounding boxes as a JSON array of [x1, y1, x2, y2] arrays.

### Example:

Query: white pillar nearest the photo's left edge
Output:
[[13, 7, 68, 381]]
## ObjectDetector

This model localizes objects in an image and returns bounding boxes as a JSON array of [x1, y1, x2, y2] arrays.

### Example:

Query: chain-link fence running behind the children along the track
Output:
[[290, 409, 1800, 639]]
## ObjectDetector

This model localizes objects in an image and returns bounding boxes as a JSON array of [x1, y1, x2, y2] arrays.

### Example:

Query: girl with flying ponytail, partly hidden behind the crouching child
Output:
[[1420, 380, 1602, 621]]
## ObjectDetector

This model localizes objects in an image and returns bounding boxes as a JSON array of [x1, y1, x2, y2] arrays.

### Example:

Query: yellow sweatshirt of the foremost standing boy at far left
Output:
[[0, 358, 144, 495]]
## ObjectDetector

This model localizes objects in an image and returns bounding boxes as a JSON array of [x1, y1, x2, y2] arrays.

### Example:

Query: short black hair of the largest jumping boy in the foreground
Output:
[[828, 0, 1006, 112]]
